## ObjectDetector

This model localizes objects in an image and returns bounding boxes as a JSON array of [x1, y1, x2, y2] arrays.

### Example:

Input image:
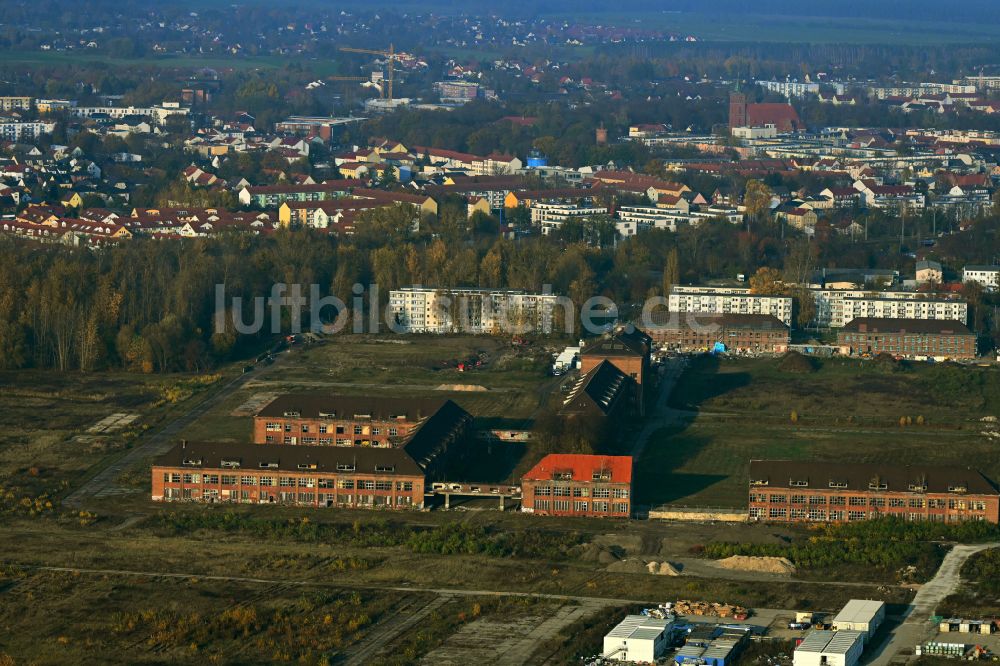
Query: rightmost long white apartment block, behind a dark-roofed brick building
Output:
[[811, 289, 969, 328]]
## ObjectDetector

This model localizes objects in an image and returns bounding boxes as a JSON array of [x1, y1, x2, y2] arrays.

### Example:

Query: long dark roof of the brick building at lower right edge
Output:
[[750, 460, 998, 495]]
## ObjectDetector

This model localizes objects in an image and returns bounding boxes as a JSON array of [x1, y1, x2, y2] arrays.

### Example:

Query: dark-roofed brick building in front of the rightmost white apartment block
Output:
[[837, 317, 976, 361]]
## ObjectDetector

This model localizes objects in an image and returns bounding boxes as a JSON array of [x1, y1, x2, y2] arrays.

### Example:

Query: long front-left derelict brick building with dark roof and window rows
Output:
[[152, 441, 425, 509]]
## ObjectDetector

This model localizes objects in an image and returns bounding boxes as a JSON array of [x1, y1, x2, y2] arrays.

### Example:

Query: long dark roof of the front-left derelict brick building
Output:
[[154, 442, 424, 477]]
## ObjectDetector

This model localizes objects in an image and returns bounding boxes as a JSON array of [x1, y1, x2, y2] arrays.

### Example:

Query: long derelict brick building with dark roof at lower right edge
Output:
[[749, 460, 1000, 523]]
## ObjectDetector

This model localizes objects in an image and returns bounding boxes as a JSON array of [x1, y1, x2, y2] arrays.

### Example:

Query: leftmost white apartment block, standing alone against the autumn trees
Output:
[[389, 287, 558, 334]]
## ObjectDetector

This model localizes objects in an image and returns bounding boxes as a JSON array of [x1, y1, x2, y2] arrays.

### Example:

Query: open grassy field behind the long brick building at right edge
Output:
[[637, 358, 1000, 507]]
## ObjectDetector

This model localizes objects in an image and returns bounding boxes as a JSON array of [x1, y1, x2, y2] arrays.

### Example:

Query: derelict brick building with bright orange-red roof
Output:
[[521, 453, 632, 518]]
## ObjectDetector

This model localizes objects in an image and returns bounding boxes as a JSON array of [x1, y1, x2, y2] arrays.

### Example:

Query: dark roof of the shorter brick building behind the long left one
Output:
[[257, 393, 450, 422]]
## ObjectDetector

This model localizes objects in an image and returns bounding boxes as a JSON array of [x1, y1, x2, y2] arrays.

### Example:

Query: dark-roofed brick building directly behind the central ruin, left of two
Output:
[[645, 310, 789, 354]]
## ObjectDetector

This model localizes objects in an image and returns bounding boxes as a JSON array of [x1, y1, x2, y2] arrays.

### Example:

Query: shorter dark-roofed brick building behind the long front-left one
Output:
[[253, 393, 457, 447]]
